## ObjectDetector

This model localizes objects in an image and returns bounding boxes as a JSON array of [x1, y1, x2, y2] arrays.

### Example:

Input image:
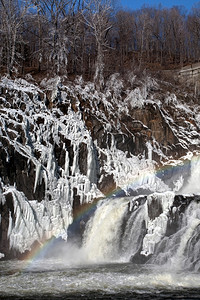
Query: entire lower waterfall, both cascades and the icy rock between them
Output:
[[82, 192, 200, 270]]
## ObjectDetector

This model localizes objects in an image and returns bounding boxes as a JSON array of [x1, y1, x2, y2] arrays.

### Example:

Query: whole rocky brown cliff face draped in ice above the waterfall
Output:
[[0, 75, 200, 257]]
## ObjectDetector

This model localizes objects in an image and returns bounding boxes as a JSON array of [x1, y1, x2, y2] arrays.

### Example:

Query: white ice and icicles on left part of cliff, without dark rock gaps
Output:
[[0, 78, 102, 253]]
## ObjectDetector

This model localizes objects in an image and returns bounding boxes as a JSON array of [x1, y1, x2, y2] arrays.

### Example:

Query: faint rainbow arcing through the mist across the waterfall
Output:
[[23, 154, 200, 270]]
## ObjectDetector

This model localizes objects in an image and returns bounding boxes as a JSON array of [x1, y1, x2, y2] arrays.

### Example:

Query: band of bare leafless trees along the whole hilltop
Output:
[[0, 0, 200, 78]]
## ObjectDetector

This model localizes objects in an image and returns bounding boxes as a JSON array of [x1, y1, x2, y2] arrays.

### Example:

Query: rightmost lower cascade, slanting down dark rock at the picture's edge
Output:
[[150, 201, 200, 271]]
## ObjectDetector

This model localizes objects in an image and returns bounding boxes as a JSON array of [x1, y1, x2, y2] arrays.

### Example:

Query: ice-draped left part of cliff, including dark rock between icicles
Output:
[[0, 78, 102, 253]]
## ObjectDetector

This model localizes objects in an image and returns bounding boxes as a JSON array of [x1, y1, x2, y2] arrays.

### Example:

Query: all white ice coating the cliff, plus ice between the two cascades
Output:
[[0, 74, 200, 255]]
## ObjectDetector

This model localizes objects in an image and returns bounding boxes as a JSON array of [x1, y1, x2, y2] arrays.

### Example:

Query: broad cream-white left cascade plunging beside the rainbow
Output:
[[83, 198, 129, 262]]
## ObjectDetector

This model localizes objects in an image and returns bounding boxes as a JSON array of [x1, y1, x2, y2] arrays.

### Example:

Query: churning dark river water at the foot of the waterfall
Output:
[[0, 259, 200, 299]]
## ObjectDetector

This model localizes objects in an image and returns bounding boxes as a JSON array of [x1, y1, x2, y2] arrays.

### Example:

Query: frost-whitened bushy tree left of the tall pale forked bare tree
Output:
[[30, 0, 77, 74]]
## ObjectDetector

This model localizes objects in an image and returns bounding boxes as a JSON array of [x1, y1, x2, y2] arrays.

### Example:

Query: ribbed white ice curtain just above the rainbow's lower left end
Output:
[[4, 188, 72, 253]]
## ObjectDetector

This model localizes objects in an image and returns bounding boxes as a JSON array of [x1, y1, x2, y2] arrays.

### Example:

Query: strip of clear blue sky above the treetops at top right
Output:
[[121, 0, 200, 11]]
